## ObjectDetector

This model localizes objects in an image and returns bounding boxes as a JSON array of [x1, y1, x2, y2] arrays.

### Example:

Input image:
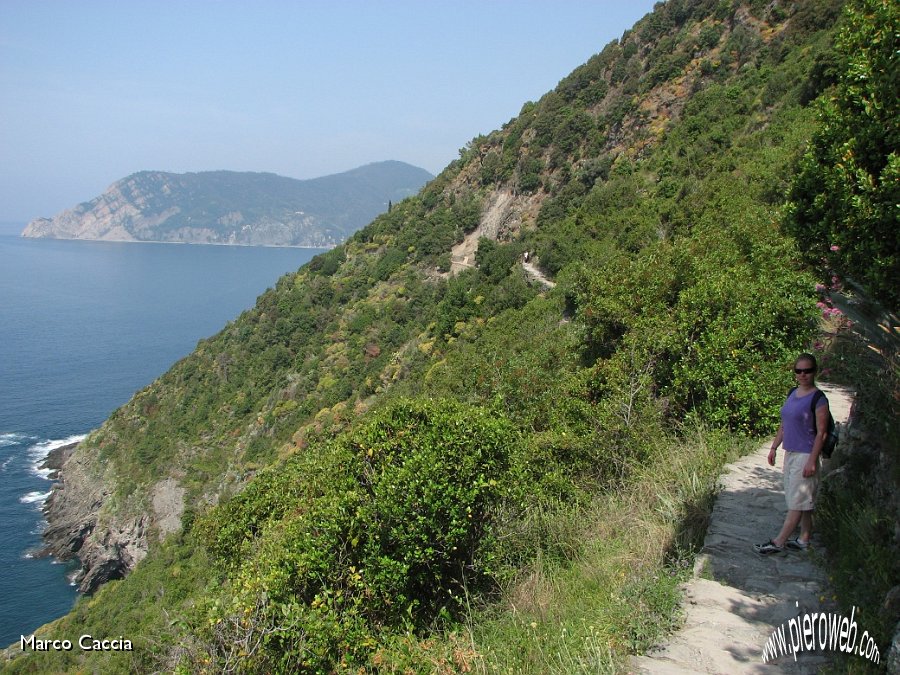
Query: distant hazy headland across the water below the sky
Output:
[[22, 161, 432, 247]]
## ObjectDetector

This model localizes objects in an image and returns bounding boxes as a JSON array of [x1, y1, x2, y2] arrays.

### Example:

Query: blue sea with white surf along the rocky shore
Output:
[[0, 234, 320, 646]]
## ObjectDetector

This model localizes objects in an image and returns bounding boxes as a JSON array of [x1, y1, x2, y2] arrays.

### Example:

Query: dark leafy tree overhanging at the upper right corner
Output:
[[786, 0, 900, 309]]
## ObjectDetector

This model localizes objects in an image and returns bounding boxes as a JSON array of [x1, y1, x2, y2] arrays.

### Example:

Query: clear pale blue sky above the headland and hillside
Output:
[[0, 0, 653, 222]]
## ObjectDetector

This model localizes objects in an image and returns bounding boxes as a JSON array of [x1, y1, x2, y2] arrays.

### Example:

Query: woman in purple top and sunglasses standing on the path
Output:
[[754, 354, 830, 555]]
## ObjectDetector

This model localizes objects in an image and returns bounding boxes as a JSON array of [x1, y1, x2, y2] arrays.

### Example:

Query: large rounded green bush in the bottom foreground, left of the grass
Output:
[[187, 400, 517, 672]]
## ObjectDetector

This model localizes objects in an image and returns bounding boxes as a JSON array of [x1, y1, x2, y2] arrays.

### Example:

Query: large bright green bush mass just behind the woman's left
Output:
[[575, 219, 816, 433]]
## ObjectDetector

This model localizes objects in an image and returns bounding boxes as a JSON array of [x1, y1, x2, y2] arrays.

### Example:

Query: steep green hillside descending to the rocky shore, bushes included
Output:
[[14, 2, 856, 672]]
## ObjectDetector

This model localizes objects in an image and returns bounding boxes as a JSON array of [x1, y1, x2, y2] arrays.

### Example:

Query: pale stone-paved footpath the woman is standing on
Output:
[[632, 385, 852, 674]]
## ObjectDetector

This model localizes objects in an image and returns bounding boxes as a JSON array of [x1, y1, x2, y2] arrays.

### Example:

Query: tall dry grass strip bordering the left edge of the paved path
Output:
[[456, 428, 752, 674]]
